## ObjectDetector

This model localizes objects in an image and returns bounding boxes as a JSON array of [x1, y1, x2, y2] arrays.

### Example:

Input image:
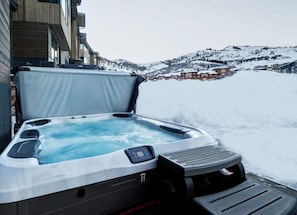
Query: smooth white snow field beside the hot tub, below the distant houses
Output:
[[137, 71, 297, 190]]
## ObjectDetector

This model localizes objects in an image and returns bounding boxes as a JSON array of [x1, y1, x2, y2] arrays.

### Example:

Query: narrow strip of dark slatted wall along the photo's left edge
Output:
[[0, 0, 11, 152]]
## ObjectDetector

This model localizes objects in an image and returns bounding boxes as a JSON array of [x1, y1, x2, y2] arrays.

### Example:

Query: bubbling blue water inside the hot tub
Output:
[[35, 118, 181, 164]]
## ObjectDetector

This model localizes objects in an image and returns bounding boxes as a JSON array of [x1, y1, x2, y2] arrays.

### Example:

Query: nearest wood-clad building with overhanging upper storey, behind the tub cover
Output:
[[11, 0, 84, 66]]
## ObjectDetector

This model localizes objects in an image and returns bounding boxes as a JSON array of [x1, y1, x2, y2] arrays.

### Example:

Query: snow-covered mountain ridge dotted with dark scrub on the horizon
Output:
[[101, 46, 297, 75]]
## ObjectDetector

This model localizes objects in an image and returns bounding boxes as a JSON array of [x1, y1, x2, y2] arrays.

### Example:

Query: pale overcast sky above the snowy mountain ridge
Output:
[[78, 0, 297, 63]]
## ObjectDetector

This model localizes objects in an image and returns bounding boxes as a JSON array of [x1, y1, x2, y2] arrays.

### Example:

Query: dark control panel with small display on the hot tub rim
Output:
[[125, 146, 155, 163]]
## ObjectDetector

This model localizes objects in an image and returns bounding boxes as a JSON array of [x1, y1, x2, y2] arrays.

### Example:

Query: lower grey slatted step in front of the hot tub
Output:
[[193, 179, 297, 215]]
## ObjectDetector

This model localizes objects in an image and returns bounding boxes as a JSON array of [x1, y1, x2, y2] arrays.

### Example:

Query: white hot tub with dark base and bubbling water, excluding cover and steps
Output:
[[0, 112, 217, 214]]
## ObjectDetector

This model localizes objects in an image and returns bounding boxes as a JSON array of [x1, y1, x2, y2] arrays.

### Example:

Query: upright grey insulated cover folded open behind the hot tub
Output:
[[14, 67, 143, 122]]
